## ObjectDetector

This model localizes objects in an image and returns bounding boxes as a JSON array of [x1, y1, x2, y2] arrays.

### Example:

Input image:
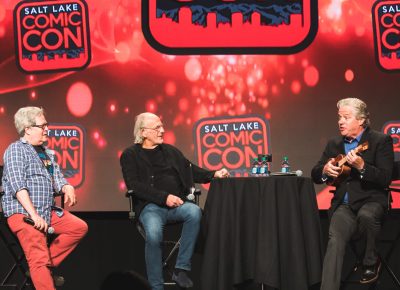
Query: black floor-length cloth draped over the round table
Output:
[[201, 176, 323, 290]]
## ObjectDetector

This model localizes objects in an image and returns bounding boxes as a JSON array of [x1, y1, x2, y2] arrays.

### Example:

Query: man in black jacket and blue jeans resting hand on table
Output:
[[120, 113, 229, 290]]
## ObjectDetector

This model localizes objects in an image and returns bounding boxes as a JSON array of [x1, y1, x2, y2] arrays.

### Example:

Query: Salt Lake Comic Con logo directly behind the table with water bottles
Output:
[[193, 115, 270, 176]]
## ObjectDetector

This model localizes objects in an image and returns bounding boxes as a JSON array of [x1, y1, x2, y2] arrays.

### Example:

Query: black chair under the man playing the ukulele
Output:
[[341, 161, 400, 290]]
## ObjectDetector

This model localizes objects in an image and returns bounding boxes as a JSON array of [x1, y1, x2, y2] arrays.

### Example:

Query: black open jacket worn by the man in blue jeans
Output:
[[120, 143, 215, 217]]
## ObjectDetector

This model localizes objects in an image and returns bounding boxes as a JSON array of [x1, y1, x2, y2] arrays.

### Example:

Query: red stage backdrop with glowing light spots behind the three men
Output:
[[0, 0, 400, 211]]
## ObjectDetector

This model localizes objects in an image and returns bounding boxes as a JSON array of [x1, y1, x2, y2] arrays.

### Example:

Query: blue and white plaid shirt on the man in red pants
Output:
[[2, 138, 68, 225]]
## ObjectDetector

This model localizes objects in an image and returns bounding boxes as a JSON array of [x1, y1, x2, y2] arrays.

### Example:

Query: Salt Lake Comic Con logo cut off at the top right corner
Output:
[[372, 0, 400, 71]]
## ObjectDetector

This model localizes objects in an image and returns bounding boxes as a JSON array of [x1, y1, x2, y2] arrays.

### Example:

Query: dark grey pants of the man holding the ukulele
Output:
[[321, 202, 384, 290]]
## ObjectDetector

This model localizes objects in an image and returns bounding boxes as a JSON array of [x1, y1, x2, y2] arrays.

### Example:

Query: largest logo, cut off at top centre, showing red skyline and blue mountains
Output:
[[142, 0, 318, 54]]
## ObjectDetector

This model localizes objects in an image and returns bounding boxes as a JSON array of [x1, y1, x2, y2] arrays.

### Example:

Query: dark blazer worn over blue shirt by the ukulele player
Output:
[[311, 128, 394, 216]]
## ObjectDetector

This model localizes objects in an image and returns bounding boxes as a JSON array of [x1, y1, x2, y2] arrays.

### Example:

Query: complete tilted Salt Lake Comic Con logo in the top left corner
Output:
[[14, 0, 91, 73]]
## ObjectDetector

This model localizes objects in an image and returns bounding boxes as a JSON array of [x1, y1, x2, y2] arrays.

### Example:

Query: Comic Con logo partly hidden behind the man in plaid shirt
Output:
[[47, 124, 85, 187]]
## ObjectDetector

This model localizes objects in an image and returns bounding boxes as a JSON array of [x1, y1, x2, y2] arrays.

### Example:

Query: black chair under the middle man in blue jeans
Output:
[[126, 189, 201, 286]]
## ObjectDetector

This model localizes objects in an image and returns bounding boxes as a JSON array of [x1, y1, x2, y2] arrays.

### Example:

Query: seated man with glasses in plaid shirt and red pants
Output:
[[2, 107, 88, 290]]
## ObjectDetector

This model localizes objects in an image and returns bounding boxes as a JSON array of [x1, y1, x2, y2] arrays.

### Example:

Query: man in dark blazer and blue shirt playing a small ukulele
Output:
[[311, 98, 394, 290]]
